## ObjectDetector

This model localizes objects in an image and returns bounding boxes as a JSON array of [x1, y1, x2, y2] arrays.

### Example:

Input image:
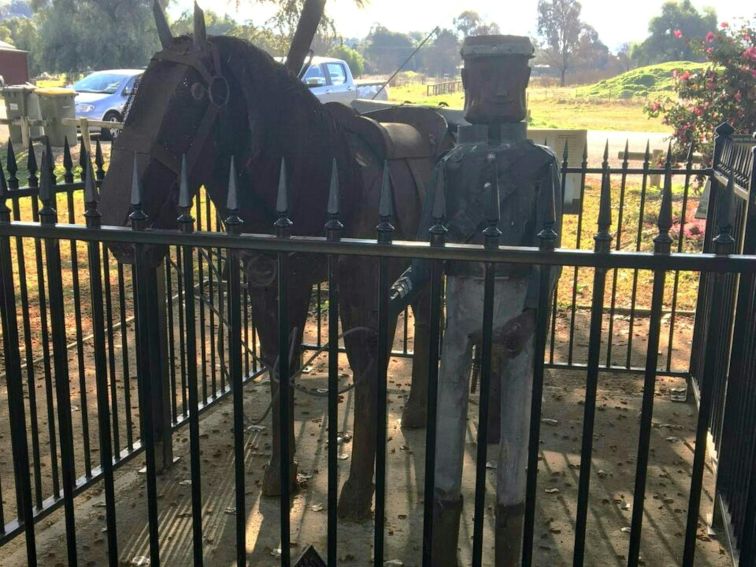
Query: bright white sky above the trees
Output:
[[171, 0, 756, 49]]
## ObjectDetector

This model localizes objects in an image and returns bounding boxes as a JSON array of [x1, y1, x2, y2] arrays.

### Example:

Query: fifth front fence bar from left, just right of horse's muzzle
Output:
[[178, 157, 203, 567]]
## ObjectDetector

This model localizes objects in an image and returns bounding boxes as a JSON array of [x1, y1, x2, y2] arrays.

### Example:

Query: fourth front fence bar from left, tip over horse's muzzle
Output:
[[129, 155, 160, 567]]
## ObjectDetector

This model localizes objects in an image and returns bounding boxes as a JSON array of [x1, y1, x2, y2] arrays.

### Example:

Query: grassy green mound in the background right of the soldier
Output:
[[577, 61, 706, 98]]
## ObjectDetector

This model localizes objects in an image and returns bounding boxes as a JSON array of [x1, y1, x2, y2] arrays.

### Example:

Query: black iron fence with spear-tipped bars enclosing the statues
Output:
[[0, 126, 756, 565]]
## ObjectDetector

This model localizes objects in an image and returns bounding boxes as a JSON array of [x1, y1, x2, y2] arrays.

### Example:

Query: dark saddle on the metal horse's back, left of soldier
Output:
[[326, 103, 453, 239]]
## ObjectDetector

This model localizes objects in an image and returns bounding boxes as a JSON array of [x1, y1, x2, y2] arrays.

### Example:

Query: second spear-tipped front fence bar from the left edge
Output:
[[39, 153, 77, 565]]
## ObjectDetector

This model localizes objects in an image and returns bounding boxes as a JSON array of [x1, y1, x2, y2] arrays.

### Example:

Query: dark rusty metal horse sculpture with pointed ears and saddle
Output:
[[96, 2, 447, 520]]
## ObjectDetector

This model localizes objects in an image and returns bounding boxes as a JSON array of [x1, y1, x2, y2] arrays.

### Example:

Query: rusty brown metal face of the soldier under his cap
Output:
[[462, 55, 530, 124]]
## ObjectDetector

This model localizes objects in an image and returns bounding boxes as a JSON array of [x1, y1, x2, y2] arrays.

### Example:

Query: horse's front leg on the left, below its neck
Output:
[[250, 278, 312, 496]]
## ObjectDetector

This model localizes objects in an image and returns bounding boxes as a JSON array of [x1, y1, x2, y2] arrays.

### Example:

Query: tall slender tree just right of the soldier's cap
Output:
[[538, 0, 583, 86]]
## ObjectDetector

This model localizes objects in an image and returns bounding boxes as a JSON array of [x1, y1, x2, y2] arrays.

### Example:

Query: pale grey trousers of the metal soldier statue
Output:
[[435, 276, 533, 507]]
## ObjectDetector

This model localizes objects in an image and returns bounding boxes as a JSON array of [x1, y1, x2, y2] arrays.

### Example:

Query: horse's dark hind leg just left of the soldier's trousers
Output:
[[402, 292, 430, 429]]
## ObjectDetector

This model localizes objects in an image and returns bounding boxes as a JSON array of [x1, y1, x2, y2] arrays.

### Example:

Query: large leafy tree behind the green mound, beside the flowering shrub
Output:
[[633, 0, 717, 65]]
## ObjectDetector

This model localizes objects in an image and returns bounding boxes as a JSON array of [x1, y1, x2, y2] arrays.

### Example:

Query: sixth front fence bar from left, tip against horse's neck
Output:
[[224, 156, 248, 565]]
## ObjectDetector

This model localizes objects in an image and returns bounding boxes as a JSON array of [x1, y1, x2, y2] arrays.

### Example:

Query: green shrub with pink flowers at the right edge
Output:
[[644, 23, 756, 161]]
